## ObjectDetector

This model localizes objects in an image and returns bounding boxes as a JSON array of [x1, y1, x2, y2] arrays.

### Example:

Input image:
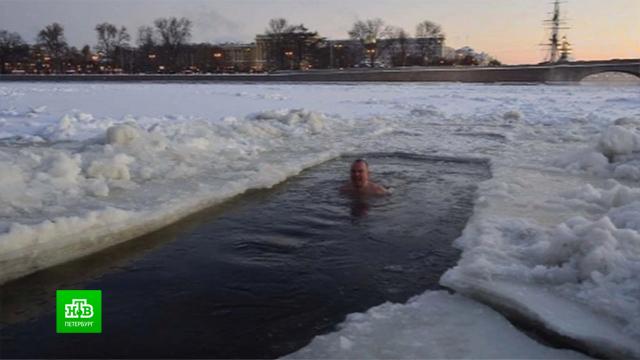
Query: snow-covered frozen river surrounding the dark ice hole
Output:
[[0, 83, 640, 357]]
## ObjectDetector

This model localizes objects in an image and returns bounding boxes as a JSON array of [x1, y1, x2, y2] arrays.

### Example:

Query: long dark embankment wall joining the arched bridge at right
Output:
[[0, 59, 640, 83]]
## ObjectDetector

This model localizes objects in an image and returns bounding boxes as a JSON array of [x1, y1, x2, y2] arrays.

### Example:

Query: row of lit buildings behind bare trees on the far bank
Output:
[[0, 30, 445, 74]]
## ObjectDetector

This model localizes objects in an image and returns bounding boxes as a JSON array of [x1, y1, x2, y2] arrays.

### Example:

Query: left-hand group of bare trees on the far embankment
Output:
[[0, 17, 198, 73]]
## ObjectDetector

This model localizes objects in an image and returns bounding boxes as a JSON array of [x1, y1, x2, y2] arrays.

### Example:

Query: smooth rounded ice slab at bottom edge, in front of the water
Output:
[[285, 291, 586, 359]]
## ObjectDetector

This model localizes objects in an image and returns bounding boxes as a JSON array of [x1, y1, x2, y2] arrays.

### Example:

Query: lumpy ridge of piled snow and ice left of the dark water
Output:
[[0, 105, 384, 282]]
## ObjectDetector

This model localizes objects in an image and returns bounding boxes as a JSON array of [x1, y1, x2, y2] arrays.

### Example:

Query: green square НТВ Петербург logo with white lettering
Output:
[[56, 290, 102, 333]]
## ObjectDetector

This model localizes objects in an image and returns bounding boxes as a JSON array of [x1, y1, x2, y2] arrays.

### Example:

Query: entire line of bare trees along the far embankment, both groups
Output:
[[0, 17, 500, 73]]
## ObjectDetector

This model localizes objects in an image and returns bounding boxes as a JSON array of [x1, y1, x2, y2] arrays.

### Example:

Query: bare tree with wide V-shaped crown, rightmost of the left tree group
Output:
[[154, 17, 192, 70]]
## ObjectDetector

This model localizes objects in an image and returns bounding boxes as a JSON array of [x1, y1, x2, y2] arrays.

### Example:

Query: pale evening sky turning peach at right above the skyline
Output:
[[0, 0, 640, 64]]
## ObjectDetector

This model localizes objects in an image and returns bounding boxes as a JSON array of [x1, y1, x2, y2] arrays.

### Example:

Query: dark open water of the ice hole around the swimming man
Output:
[[0, 154, 489, 358]]
